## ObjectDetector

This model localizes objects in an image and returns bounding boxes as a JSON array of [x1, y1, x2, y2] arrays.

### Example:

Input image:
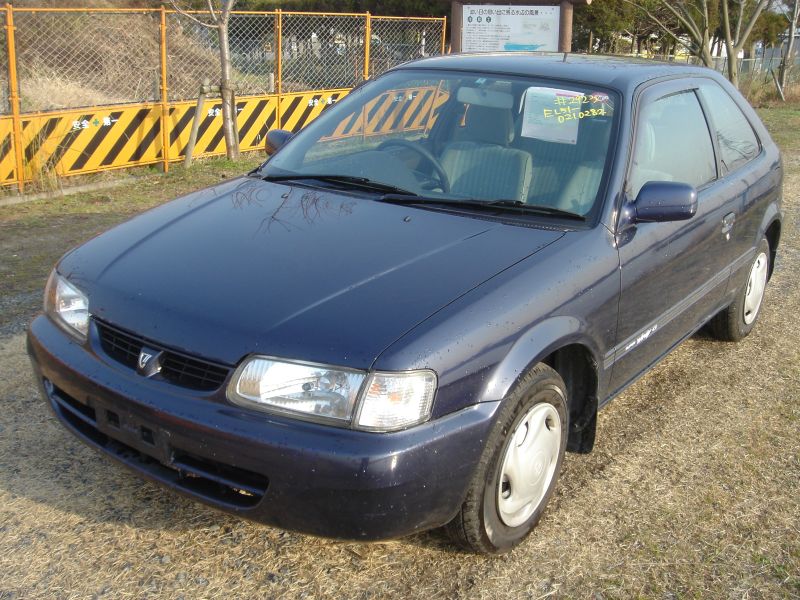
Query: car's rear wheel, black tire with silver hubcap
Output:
[[709, 238, 770, 342]]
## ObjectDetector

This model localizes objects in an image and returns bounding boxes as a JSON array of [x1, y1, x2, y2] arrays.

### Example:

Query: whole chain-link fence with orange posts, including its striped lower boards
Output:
[[0, 3, 445, 191]]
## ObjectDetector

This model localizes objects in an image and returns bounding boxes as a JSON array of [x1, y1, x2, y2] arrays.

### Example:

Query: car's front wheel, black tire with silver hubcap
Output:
[[446, 364, 569, 554]]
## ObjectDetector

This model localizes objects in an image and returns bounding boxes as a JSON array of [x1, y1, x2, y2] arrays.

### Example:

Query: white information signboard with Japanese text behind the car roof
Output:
[[461, 4, 560, 52]]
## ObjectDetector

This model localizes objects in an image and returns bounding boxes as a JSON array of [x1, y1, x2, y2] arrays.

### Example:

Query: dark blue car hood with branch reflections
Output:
[[59, 178, 563, 368]]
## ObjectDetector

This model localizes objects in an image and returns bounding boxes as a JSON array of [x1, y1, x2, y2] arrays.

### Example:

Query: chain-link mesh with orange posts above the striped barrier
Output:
[[0, 7, 445, 114]]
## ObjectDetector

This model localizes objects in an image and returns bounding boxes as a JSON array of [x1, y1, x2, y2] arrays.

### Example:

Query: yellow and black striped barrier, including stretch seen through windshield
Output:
[[0, 87, 454, 184]]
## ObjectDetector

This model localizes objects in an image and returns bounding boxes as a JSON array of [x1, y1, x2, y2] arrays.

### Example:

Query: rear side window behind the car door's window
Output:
[[700, 81, 759, 173]]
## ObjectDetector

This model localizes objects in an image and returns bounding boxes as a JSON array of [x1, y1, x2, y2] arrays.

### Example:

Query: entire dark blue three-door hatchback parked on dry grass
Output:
[[28, 54, 782, 552]]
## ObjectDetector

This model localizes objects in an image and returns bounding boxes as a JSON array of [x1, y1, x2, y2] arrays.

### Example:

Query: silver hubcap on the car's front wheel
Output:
[[497, 402, 561, 527]]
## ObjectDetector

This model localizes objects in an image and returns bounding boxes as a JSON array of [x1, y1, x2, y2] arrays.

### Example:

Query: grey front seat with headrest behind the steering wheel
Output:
[[441, 104, 533, 202]]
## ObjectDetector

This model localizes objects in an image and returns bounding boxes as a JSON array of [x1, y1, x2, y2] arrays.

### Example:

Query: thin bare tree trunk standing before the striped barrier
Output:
[[169, 0, 239, 160]]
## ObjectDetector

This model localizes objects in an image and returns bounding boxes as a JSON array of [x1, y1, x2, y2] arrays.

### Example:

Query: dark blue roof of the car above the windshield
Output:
[[397, 52, 720, 93]]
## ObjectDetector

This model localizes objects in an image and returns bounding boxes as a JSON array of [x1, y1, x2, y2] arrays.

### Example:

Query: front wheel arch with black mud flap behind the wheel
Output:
[[484, 317, 601, 453]]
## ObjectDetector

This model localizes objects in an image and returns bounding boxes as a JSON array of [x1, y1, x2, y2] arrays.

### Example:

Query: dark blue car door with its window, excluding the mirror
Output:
[[610, 80, 733, 391]]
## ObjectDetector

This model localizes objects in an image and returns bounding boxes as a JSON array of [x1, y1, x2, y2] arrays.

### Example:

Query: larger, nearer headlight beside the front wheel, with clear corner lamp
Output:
[[228, 356, 436, 431]]
